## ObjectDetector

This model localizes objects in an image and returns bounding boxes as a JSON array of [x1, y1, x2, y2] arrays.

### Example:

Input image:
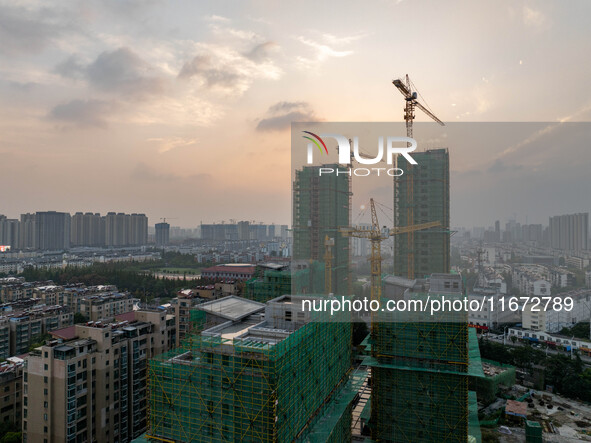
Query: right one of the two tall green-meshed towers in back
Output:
[[394, 149, 450, 278]]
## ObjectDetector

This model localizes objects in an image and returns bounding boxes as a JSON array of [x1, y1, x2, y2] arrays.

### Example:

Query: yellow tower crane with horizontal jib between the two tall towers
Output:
[[339, 198, 441, 329]]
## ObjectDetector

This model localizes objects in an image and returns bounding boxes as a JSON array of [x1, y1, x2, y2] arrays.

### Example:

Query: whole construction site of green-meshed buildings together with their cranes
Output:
[[147, 76, 485, 443]]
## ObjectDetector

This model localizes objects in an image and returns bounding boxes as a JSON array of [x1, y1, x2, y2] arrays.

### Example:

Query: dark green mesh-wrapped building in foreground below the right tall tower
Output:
[[364, 274, 482, 443]]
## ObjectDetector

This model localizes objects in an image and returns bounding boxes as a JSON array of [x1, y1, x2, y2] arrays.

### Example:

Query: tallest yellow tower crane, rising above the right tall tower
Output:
[[392, 74, 445, 279]]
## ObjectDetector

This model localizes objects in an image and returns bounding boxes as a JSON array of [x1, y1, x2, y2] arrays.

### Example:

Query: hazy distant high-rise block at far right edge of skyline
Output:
[[549, 212, 589, 251]]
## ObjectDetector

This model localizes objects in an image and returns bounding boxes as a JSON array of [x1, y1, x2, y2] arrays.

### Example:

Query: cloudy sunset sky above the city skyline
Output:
[[0, 0, 591, 227]]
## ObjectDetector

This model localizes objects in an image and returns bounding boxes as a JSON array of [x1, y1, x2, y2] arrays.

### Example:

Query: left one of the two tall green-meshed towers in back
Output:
[[292, 165, 351, 295]]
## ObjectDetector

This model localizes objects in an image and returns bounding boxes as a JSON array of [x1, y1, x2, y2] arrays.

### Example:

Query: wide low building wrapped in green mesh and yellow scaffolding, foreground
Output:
[[147, 296, 354, 442]]
